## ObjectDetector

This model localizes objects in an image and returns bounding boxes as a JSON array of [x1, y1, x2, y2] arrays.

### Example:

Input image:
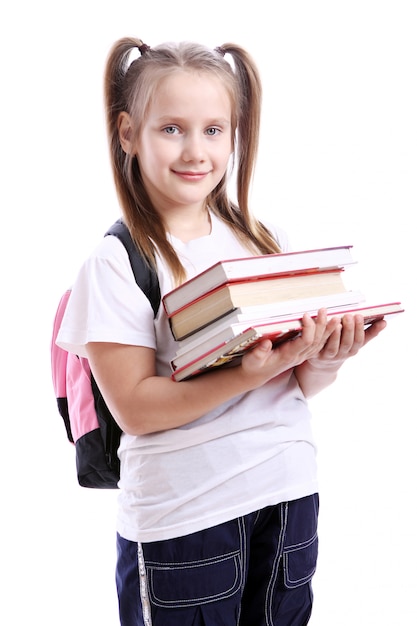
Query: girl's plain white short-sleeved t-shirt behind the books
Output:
[[57, 215, 317, 542]]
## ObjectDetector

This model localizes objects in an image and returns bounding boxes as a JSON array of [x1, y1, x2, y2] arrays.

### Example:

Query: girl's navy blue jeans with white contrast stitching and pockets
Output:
[[116, 494, 319, 626]]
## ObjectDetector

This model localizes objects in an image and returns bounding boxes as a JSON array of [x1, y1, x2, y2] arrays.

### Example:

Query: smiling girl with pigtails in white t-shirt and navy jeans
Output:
[[58, 38, 385, 626]]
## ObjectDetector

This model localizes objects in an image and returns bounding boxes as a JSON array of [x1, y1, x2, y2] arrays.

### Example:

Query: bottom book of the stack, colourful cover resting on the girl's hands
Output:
[[171, 302, 404, 382]]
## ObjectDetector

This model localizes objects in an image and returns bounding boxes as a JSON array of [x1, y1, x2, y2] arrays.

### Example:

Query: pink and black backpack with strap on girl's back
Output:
[[51, 220, 161, 489]]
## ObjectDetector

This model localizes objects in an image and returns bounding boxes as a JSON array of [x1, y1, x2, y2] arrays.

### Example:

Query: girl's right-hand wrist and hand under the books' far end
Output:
[[295, 315, 386, 397]]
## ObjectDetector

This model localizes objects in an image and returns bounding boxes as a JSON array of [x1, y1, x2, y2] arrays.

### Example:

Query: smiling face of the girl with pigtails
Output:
[[123, 71, 232, 216]]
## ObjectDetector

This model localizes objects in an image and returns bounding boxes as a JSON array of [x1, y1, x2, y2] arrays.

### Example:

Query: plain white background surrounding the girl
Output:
[[0, 0, 417, 626]]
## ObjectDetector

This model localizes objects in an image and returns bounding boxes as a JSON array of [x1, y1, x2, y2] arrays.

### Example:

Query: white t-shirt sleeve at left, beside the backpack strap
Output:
[[57, 236, 155, 356]]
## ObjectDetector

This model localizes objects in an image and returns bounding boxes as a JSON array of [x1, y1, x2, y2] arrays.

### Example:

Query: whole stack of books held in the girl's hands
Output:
[[162, 246, 404, 381]]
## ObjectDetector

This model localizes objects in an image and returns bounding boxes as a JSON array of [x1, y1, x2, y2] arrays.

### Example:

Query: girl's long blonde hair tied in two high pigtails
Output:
[[105, 37, 280, 283]]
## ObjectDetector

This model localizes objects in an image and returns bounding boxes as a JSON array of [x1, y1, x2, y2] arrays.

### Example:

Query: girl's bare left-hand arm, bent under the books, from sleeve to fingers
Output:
[[86, 311, 334, 435]]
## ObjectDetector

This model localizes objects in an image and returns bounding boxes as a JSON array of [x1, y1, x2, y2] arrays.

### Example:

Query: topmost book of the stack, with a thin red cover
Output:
[[162, 245, 355, 316]]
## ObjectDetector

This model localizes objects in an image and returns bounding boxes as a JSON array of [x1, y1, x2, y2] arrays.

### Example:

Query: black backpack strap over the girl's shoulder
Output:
[[105, 219, 161, 317]]
